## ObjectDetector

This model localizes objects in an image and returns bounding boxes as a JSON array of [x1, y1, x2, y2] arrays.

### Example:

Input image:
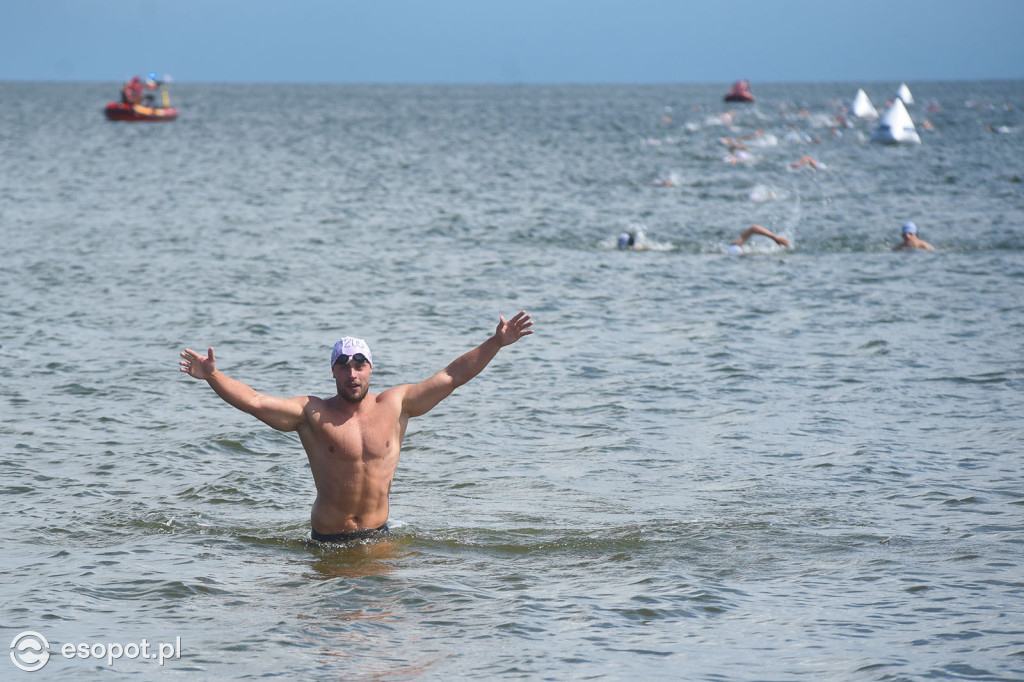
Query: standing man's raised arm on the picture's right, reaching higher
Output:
[[402, 310, 534, 417]]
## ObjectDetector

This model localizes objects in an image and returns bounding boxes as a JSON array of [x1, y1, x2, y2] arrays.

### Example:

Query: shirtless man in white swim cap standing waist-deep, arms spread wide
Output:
[[179, 310, 534, 542]]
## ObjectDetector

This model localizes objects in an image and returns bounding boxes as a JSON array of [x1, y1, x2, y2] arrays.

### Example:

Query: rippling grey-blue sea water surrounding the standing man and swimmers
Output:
[[0, 81, 1024, 680]]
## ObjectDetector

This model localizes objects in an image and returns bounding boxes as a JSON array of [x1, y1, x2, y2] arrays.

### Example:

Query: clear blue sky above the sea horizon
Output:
[[0, 0, 1024, 83]]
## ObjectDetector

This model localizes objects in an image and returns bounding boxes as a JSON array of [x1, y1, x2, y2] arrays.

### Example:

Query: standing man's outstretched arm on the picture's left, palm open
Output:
[[178, 348, 308, 431]]
